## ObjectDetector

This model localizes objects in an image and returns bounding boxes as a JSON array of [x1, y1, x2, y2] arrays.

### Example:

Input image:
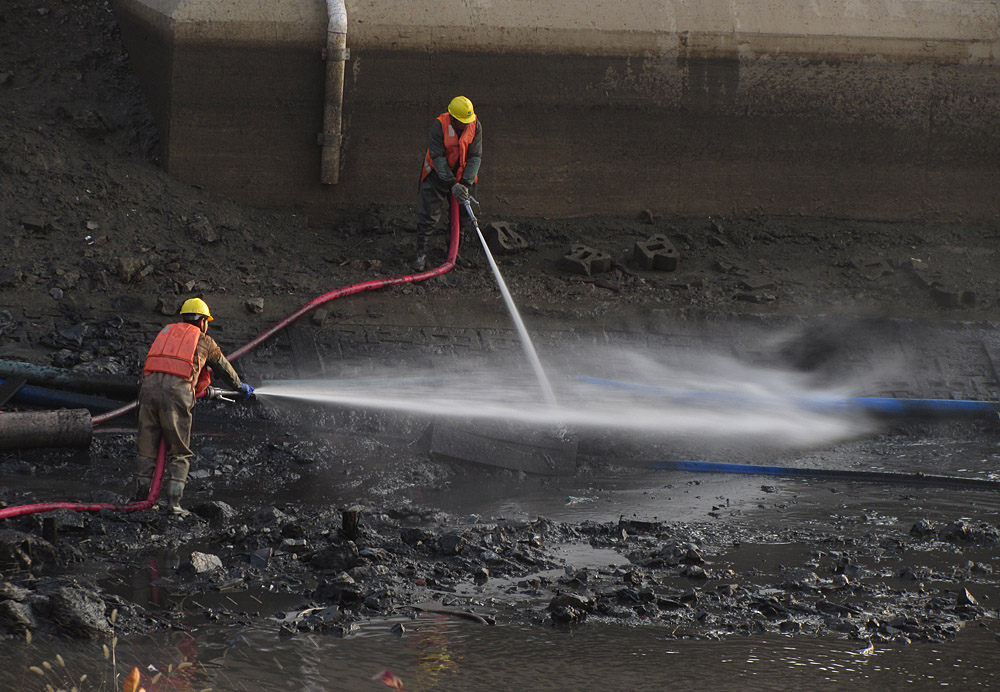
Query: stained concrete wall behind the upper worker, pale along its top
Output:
[[114, 0, 1000, 223]]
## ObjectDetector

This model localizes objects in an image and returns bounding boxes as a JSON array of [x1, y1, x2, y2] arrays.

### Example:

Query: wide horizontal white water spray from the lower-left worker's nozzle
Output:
[[257, 345, 870, 448]]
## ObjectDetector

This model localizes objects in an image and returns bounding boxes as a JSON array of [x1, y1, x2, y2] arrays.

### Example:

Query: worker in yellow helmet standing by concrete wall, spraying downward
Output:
[[413, 96, 483, 271]]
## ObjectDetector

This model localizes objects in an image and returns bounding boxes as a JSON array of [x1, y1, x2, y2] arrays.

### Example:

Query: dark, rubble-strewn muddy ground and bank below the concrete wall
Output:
[[0, 0, 1000, 641]]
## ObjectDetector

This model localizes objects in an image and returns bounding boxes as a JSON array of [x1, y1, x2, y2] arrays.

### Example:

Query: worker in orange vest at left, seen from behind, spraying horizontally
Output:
[[135, 298, 253, 517]]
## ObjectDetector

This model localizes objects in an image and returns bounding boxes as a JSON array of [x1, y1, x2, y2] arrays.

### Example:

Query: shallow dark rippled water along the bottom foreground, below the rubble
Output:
[[0, 615, 1000, 692]]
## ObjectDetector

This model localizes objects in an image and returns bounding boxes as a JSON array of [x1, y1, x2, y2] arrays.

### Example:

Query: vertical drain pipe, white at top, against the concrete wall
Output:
[[319, 0, 350, 185]]
